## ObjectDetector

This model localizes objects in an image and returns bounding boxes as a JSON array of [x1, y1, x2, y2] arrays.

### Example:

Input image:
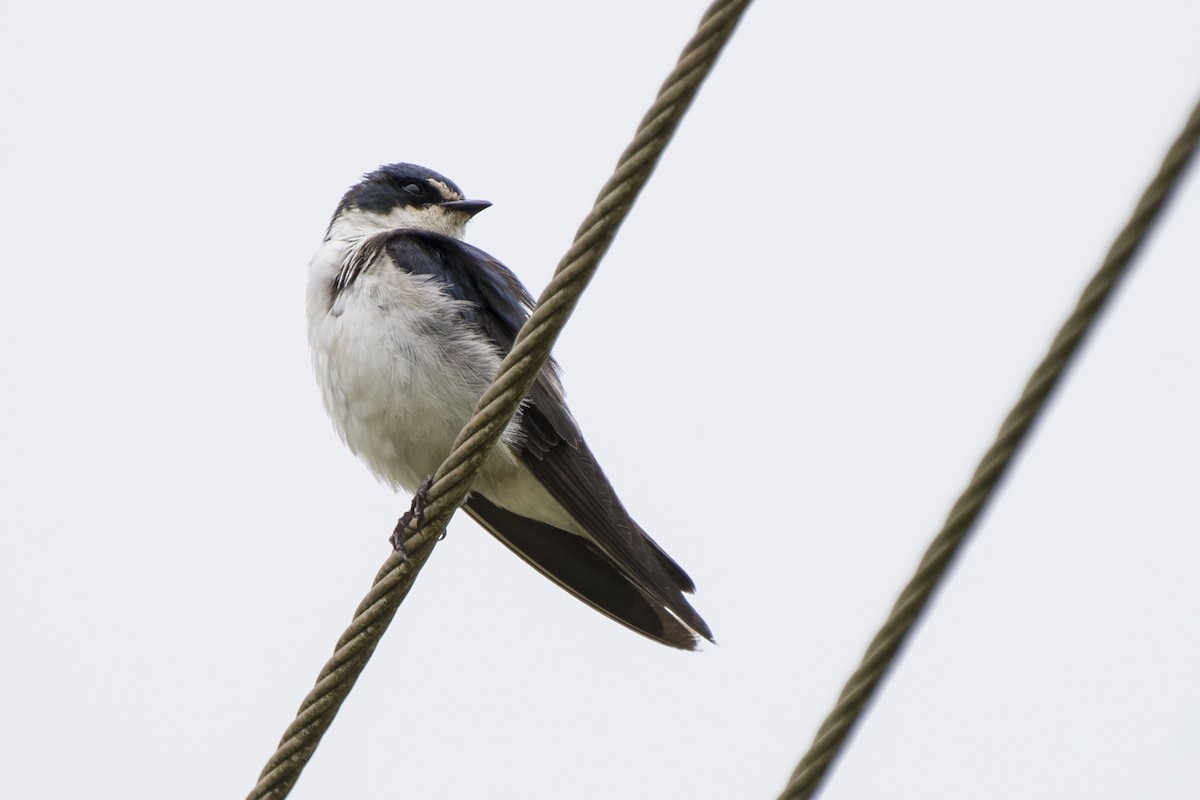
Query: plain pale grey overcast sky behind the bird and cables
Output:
[[0, 0, 1200, 800]]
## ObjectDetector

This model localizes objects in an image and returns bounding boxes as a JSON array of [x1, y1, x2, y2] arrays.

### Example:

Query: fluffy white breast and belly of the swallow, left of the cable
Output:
[[307, 240, 514, 492]]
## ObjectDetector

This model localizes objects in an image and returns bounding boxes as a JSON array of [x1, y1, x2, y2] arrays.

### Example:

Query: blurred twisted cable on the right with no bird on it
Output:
[[780, 97, 1200, 800]]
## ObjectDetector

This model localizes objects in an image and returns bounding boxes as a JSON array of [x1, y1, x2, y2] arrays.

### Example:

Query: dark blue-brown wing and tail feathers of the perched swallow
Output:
[[384, 230, 713, 646]]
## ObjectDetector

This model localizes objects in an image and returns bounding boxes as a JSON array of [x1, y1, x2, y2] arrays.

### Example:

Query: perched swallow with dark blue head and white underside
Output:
[[307, 164, 713, 650]]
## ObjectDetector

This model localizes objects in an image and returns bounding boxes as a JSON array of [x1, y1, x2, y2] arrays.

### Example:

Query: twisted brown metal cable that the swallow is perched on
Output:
[[248, 0, 750, 800]]
